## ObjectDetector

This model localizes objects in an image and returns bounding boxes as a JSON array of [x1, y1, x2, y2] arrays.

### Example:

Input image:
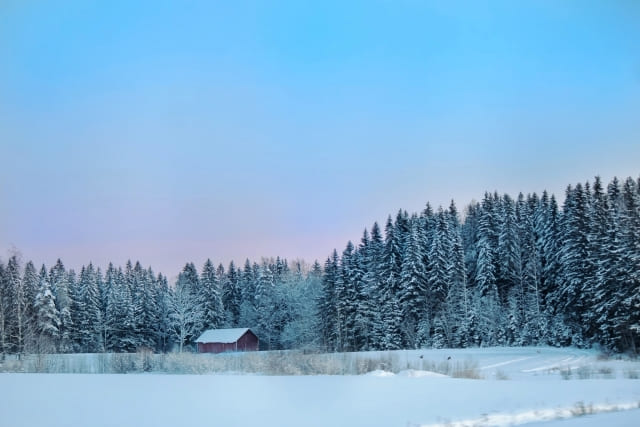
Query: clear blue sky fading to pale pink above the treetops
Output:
[[0, 0, 640, 277]]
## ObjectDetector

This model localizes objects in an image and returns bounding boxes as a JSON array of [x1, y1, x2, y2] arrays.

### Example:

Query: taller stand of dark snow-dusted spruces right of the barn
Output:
[[319, 177, 640, 353]]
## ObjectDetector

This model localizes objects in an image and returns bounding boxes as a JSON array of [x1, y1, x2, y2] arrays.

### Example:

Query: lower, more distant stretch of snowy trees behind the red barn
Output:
[[0, 254, 322, 354]]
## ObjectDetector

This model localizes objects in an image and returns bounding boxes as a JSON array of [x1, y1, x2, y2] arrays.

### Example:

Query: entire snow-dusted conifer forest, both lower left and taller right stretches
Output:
[[0, 177, 640, 354]]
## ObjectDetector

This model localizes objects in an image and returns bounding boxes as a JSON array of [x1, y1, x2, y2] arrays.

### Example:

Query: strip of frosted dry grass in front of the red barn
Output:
[[0, 350, 482, 379]]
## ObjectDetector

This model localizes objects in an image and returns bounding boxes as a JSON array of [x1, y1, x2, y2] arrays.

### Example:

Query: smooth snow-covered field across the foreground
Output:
[[0, 348, 640, 427]]
